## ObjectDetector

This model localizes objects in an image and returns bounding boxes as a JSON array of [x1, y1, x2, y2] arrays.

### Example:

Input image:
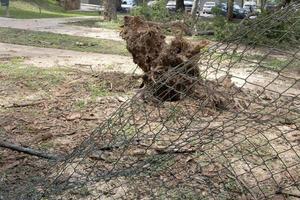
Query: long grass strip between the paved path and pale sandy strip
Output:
[[0, 28, 129, 55]]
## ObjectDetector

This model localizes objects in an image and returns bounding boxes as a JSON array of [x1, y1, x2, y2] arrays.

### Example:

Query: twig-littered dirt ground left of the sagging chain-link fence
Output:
[[0, 54, 140, 189]]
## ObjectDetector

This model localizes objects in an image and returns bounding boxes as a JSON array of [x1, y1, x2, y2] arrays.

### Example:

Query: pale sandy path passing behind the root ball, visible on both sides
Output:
[[0, 43, 300, 96]]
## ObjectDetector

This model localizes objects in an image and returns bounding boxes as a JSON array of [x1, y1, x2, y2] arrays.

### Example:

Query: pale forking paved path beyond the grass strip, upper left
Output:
[[0, 17, 122, 41]]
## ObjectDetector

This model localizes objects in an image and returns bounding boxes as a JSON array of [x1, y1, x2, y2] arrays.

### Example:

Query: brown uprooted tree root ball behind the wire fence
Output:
[[120, 16, 237, 107]]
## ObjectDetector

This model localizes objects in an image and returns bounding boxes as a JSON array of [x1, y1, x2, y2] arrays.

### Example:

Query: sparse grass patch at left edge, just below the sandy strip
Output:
[[0, 60, 69, 90]]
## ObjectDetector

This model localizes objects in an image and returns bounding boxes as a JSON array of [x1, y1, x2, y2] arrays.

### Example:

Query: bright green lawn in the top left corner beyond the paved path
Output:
[[0, 0, 99, 19]]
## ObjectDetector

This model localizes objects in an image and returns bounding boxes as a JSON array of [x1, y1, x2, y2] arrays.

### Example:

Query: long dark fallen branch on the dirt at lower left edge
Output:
[[0, 141, 63, 160]]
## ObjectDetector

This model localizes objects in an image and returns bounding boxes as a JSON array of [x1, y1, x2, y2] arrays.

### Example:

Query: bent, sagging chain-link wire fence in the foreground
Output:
[[0, 1, 300, 200]]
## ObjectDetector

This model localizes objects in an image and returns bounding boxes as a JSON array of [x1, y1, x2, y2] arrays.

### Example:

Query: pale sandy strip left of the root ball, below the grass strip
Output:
[[0, 43, 136, 73]]
